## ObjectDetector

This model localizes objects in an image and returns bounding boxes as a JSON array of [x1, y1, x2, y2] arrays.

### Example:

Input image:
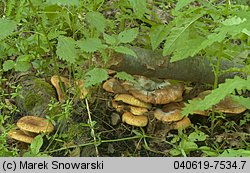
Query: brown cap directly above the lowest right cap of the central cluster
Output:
[[154, 103, 183, 122]]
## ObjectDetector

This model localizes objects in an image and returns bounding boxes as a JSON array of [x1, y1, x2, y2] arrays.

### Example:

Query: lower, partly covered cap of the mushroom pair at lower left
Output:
[[8, 129, 34, 144]]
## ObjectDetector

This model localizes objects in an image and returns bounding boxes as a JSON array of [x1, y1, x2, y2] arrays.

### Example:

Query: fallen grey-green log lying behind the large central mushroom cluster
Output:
[[109, 47, 242, 84]]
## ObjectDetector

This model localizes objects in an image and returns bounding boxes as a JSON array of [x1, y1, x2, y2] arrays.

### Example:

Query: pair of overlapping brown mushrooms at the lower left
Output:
[[8, 116, 54, 144]]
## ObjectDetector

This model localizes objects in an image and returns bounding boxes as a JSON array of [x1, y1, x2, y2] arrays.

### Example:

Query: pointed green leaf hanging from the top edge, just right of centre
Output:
[[129, 0, 147, 19]]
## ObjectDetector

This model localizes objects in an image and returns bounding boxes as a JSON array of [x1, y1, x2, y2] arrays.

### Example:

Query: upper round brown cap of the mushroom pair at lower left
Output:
[[17, 116, 54, 133]]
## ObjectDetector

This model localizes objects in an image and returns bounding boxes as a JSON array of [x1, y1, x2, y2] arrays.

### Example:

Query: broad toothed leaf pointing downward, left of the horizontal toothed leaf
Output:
[[56, 36, 78, 64]]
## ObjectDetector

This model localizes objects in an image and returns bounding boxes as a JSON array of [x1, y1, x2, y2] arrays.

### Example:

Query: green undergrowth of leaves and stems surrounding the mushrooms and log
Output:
[[0, 0, 250, 156]]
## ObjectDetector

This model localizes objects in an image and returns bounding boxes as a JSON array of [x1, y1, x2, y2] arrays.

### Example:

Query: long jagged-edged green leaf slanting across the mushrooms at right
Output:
[[182, 76, 250, 115]]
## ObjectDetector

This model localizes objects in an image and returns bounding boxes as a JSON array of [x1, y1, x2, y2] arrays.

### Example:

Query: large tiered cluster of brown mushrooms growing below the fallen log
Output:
[[103, 75, 191, 129]]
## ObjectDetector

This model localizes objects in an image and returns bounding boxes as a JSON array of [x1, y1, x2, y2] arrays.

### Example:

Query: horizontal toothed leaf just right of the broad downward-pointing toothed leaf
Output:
[[77, 38, 106, 53]]
